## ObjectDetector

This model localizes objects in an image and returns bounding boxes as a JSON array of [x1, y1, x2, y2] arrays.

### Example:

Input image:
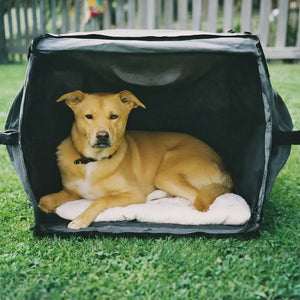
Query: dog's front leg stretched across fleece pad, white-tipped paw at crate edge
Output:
[[68, 193, 146, 229]]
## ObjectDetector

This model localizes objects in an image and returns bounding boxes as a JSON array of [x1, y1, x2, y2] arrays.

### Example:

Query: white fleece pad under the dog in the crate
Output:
[[56, 190, 251, 225]]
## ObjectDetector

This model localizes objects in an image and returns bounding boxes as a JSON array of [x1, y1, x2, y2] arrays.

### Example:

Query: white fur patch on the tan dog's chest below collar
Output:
[[66, 163, 105, 200]]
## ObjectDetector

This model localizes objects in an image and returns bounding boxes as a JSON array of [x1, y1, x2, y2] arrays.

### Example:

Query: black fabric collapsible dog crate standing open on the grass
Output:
[[1, 31, 298, 234]]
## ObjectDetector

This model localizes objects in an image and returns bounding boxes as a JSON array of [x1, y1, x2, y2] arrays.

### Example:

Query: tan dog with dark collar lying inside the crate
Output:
[[39, 91, 232, 229]]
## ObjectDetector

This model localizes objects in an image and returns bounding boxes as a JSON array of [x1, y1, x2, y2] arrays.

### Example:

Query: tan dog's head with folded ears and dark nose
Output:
[[57, 90, 145, 150]]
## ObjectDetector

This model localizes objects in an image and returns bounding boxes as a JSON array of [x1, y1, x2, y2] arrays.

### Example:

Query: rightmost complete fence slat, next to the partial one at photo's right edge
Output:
[[275, 0, 290, 47]]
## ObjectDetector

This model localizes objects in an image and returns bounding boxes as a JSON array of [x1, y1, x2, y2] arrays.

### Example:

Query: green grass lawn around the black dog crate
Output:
[[0, 63, 300, 300]]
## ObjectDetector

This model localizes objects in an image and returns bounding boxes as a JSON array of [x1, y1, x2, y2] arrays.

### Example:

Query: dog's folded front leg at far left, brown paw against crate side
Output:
[[39, 190, 80, 213]]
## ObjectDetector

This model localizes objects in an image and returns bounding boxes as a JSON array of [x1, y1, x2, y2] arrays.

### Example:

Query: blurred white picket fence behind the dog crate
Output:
[[0, 0, 300, 60]]
